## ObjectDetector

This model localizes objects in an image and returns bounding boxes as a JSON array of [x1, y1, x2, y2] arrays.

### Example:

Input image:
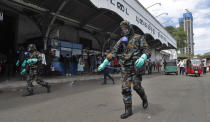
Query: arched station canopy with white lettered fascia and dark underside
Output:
[[2, 0, 176, 49]]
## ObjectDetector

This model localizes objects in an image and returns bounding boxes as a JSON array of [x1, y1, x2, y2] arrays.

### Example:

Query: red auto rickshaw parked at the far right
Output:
[[185, 58, 203, 77]]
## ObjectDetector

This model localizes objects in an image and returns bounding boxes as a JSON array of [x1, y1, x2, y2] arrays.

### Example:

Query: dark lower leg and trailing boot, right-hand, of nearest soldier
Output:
[[134, 86, 148, 109]]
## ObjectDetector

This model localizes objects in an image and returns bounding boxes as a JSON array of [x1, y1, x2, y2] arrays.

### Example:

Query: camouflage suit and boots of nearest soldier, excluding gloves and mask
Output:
[[107, 21, 151, 119]]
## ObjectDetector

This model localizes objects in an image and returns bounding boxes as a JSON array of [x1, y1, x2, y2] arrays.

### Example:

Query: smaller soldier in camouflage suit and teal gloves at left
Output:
[[21, 44, 50, 96]]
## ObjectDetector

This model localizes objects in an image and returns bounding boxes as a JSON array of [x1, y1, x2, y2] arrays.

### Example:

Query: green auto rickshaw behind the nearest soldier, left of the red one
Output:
[[164, 60, 178, 75]]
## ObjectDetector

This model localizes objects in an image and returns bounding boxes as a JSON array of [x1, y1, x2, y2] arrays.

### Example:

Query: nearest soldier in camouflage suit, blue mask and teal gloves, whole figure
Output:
[[98, 20, 151, 119]]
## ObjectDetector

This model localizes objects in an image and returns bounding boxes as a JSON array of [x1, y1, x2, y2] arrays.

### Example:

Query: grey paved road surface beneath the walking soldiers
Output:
[[0, 73, 210, 122]]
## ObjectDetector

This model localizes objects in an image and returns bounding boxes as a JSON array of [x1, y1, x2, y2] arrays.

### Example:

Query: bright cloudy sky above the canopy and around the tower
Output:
[[139, 0, 210, 54]]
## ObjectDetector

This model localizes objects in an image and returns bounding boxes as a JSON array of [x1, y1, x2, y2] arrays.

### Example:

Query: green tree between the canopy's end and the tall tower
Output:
[[165, 26, 187, 50]]
